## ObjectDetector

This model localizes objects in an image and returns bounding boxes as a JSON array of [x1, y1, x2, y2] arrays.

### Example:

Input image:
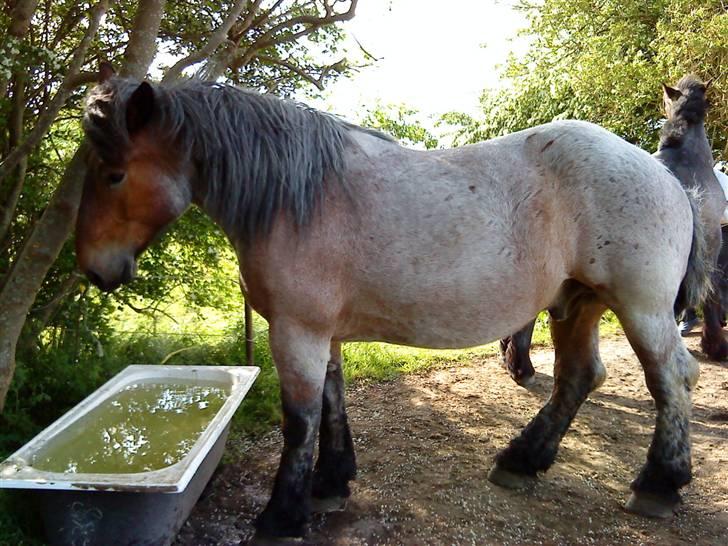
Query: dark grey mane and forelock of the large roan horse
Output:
[[84, 78, 390, 241]]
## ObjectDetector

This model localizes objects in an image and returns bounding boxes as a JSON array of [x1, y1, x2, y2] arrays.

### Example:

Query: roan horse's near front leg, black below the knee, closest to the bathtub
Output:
[[256, 320, 330, 538]]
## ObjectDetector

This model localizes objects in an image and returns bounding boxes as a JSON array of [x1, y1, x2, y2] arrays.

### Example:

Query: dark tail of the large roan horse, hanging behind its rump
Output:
[[675, 188, 714, 314]]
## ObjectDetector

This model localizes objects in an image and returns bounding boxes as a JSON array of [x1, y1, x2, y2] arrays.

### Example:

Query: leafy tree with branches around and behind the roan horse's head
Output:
[[0, 0, 357, 410]]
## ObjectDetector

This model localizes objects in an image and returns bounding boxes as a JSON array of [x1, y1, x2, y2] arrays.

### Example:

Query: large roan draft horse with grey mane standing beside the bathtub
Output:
[[75, 76, 707, 542]]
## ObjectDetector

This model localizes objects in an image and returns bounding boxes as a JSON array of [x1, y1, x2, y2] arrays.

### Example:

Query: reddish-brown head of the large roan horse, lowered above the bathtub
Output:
[[76, 78, 191, 290]]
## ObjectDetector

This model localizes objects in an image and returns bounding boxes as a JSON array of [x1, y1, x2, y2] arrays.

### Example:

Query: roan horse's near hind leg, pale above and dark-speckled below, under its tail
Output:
[[618, 312, 698, 517]]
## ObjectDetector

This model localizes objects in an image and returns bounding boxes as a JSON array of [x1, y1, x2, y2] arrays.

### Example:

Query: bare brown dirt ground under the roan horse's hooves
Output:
[[178, 336, 728, 546]]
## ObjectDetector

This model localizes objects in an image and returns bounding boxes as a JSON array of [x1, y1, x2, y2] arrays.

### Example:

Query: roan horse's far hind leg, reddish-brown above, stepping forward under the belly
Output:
[[488, 292, 606, 487]]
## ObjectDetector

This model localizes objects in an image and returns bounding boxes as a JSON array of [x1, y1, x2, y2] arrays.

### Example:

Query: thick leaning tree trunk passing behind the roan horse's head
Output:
[[0, 0, 165, 412]]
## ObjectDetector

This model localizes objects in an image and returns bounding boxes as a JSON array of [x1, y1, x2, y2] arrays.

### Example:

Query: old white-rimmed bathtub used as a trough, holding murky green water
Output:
[[0, 365, 260, 546]]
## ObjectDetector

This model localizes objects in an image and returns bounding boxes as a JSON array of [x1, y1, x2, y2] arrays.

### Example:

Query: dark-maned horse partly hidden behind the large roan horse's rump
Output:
[[500, 75, 728, 387]]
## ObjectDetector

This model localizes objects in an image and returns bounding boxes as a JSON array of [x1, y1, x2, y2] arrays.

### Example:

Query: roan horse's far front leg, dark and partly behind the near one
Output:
[[313, 342, 356, 512]]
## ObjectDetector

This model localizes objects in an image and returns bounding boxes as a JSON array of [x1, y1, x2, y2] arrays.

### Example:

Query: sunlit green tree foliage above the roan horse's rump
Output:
[[456, 0, 728, 159]]
